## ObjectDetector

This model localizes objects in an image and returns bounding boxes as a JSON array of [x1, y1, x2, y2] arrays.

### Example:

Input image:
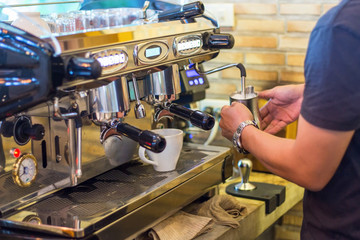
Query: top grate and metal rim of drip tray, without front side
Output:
[[0, 145, 228, 237]]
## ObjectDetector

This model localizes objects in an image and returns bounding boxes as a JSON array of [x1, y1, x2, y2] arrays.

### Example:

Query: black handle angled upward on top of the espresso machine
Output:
[[158, 1, 205, 22]]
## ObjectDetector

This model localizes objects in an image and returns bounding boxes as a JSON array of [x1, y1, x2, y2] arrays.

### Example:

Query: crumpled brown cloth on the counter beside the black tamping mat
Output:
[[192, 195, 247, 228]]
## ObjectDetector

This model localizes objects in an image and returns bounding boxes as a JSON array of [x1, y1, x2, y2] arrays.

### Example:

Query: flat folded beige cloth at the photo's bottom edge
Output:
[[148, 211, 214, 240]]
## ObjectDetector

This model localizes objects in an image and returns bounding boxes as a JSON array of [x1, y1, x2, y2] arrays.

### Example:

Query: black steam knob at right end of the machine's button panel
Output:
[[203, 32, 235, 49]]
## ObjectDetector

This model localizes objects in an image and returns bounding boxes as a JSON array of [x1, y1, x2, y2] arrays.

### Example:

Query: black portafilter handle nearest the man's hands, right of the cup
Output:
[[167, 103, 215, 130]]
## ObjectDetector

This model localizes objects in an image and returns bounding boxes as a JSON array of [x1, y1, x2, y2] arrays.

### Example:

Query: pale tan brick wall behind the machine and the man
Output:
[[203, 0, 340, 99]]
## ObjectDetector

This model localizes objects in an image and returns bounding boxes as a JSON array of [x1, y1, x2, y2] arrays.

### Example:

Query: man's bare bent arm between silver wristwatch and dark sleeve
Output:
[[241, 117, 354, 191]]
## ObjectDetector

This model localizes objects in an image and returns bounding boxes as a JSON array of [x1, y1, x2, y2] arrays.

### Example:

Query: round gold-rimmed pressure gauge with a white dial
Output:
[[12, 153, 37, 187]]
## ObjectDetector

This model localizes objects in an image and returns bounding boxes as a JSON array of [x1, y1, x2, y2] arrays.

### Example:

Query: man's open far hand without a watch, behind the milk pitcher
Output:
[[259, 84, 304, 134]]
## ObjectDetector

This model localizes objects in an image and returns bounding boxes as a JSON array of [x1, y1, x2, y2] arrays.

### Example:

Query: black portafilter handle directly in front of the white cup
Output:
[[116, 123, 166, 153]]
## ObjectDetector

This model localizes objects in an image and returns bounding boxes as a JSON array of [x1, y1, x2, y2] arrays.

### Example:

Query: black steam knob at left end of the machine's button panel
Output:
[[66, 57, 102, 80]]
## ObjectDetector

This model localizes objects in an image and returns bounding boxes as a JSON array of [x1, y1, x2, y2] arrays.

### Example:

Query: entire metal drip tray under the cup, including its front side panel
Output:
[[0, 144, 230, 239]]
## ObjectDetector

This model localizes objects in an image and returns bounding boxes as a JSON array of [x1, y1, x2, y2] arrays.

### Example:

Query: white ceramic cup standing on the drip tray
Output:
[[139, 128, 183, 172]]
